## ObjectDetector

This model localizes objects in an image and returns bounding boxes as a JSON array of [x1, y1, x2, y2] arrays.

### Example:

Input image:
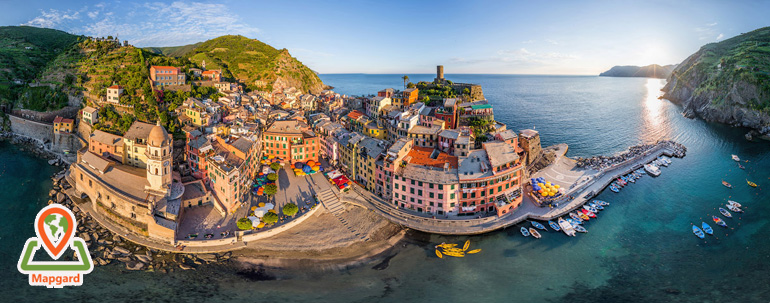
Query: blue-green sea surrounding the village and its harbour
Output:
[[0, 74, 770, 302]]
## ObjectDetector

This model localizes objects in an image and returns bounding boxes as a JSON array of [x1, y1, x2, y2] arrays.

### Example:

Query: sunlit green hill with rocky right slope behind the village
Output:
[[180, 35, 325, 93]]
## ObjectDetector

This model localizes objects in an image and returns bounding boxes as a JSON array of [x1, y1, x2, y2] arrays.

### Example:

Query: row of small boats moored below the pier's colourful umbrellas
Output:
[[520, 200, 610, 239]]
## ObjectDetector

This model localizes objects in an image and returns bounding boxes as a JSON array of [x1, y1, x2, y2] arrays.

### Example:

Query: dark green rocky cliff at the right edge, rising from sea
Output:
[[663, 27, 770, 135]]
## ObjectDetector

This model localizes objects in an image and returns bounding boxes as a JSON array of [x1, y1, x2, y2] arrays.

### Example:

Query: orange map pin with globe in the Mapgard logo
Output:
[[35, 204, 77, 260]]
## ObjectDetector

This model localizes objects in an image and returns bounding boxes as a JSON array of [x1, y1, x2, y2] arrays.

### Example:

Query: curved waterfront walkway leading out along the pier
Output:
[[342, 144, 673, 235]]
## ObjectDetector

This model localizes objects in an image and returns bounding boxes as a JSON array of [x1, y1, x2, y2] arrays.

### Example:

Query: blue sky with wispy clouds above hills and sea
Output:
[[0, 0, 770, 75]]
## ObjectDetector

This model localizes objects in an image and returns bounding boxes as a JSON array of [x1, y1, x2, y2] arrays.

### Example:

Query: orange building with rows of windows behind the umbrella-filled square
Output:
[[262, 120, 321, 164]]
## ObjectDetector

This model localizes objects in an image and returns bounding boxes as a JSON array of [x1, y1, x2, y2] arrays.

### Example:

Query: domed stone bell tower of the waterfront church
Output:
[[146, 121, 172, 194]]
